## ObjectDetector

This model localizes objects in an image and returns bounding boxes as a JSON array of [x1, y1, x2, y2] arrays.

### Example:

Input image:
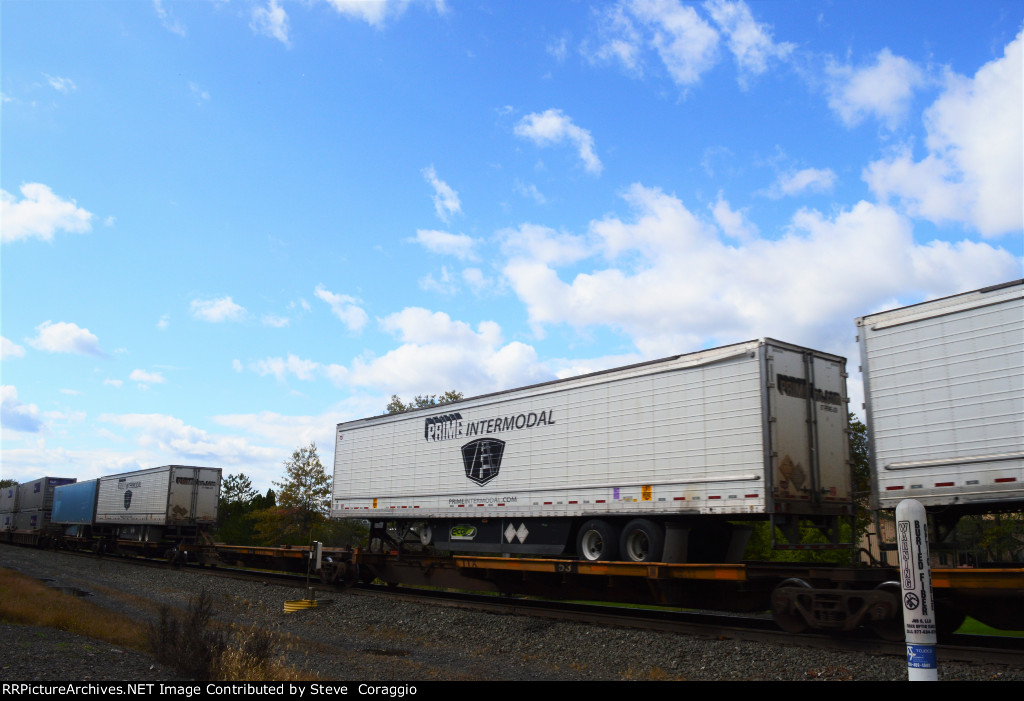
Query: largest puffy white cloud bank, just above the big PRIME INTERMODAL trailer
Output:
[[504, 184, 1020, 356]]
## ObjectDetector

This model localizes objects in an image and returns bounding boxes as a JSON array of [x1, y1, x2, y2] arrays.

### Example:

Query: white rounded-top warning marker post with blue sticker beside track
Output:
[[896, 499, 939, 682]]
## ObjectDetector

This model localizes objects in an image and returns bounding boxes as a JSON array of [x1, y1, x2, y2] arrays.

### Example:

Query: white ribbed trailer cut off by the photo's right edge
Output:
[[857, 279, 1024, 513]]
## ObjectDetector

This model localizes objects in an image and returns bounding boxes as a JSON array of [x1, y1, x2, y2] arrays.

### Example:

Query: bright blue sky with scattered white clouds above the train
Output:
[[0, 0, 1024, 489]]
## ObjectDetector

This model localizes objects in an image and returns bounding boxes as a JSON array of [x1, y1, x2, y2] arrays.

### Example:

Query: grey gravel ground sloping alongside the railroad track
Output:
[[0, 545, 1024, 682]]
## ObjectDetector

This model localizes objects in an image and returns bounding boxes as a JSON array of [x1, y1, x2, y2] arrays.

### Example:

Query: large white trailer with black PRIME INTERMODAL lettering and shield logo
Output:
[[331, 339, 853, 562]]
